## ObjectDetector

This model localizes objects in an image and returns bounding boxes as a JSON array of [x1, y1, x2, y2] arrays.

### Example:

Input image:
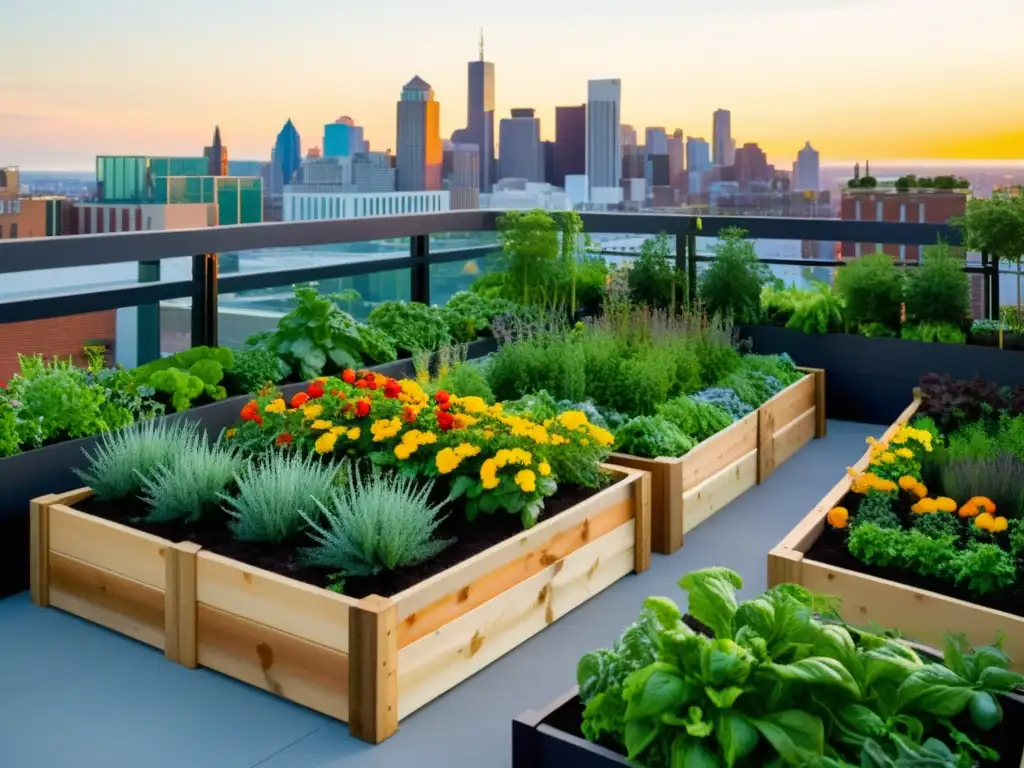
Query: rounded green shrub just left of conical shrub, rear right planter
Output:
[[836, 253, 903, 332]]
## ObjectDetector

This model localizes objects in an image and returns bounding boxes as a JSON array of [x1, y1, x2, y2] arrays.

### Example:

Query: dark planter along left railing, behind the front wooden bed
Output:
[[0, 339, 497, 598]]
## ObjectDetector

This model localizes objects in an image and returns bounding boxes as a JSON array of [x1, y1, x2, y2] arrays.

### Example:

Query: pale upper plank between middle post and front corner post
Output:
[[197, 552, 356, 653]]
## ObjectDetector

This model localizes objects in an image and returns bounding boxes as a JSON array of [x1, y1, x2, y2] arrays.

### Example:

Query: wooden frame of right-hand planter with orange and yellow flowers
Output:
[[768, 398, 1024, 672]]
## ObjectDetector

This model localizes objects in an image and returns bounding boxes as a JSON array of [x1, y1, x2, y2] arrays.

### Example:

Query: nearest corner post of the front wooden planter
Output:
[[348, 595, 398, 744]]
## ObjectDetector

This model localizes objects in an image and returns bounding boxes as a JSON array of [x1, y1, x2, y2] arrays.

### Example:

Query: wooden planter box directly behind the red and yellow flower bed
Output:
[[609, 369, 825, 555]]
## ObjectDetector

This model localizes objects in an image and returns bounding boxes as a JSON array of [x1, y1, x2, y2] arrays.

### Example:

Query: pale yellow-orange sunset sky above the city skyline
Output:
[[0, 0, 1024, 170]]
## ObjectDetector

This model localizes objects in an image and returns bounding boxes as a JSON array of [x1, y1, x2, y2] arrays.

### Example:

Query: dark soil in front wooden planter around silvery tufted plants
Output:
[[75, 485, 597, 598]]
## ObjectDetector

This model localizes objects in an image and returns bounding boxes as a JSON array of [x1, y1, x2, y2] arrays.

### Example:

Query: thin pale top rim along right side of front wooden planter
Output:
[[392, 470, 633, 633]]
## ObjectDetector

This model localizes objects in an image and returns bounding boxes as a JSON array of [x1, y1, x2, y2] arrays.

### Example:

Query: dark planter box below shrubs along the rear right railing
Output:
[[739, 326, 1024, 424]]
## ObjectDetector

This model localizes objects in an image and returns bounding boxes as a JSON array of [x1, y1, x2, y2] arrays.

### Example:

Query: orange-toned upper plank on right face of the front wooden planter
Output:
[[395, 493, 640, 648]]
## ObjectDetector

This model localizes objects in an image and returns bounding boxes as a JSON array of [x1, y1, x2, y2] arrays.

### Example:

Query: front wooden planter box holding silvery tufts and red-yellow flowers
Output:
[[31, 466, 650, 742]]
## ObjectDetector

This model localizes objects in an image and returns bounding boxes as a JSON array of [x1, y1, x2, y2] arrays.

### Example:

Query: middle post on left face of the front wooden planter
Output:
[[164, 542, 202, 670]]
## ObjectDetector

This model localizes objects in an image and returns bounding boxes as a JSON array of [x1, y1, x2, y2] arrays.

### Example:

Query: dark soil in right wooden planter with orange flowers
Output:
[[806, 494, 1024, 616]]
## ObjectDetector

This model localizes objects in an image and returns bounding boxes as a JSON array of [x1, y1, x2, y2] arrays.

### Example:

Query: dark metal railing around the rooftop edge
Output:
[[0, 210, 978, 360]]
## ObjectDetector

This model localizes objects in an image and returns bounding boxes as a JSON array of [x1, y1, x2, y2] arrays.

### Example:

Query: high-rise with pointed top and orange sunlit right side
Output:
[[396, 75, 443, 191]]
